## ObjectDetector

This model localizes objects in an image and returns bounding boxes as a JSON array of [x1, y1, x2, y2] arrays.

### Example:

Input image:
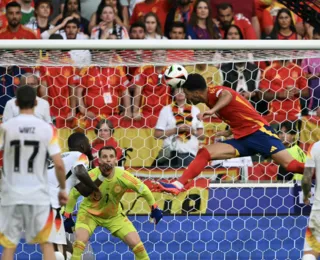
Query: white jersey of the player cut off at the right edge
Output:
[[305, 141, 320, 210]]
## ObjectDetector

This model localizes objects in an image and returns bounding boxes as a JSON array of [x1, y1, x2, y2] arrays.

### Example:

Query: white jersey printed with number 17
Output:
[[0, 114, 61, 206]]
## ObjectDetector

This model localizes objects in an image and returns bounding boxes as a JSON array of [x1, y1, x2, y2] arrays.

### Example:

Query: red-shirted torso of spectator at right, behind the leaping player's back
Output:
[[259, 60, 309, 122]]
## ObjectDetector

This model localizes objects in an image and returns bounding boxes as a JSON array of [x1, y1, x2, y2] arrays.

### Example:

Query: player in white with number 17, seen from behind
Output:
[[0, 86, 68, 260]]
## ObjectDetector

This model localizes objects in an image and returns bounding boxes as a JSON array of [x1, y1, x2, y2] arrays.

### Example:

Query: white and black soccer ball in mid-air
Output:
[[164, 64, 188, 88]]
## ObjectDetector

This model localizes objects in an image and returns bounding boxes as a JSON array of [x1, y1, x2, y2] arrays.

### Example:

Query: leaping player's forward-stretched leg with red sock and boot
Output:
[[157, 143, 239, 194]]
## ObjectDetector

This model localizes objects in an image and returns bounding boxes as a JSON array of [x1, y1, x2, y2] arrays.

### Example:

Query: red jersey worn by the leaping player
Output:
[[207, 86, 269, 139]]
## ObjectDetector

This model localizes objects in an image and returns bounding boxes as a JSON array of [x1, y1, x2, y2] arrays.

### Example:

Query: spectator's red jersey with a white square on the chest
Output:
[[80, 66, 129, 116]]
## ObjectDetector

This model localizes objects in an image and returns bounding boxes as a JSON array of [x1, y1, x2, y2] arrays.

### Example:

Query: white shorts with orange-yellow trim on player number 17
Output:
[[0, 205, 53, 248]]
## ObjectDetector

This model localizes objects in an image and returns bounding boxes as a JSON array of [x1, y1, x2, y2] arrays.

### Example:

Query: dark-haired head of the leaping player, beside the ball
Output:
[[182, 73, 207, 105]]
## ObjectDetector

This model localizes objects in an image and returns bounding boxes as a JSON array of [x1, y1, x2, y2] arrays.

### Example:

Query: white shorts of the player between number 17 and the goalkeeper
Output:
[[48, 209, 67, 245]]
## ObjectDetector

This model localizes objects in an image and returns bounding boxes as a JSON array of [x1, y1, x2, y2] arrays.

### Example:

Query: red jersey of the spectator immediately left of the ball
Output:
[[134, 66, 171, 116]]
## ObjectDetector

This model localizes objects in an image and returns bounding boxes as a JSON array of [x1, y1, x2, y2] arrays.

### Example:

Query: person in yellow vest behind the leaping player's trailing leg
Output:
[[277, 121, 307, 181]]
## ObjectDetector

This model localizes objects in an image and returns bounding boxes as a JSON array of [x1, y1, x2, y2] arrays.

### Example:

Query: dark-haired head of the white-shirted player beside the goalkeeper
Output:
[[68, 133, 93, 161]]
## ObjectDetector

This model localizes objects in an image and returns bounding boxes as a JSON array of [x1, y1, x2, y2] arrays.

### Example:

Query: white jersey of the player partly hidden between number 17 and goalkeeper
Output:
[[48, 152, 89, 209]]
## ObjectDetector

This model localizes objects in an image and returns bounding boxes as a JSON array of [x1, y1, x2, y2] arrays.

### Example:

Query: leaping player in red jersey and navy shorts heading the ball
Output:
[[158, 69, 304, 194]]
